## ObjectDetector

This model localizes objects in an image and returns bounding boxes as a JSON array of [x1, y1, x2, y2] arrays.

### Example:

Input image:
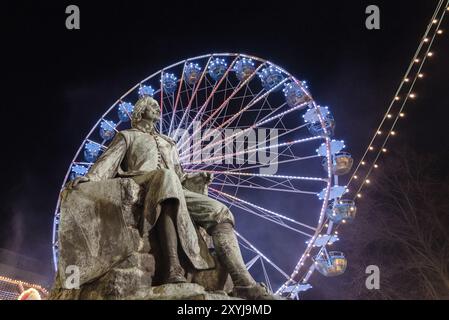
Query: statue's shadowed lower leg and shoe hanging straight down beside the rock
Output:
[[157, 199, 187, 283]]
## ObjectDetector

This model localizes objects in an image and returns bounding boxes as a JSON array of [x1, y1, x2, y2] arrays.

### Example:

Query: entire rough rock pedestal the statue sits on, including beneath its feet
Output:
[[49, 179, 232, 300]]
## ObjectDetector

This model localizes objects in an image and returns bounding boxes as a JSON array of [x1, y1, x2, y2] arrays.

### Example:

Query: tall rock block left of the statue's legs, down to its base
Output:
[[50, 179, 155, 299]]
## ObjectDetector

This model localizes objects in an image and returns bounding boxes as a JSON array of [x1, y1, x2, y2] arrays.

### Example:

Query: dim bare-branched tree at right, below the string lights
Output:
[[306, 149, 449, 299]]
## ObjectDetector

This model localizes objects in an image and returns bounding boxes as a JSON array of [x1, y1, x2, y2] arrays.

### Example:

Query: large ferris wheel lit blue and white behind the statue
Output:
[[53, 53, 356, 298]]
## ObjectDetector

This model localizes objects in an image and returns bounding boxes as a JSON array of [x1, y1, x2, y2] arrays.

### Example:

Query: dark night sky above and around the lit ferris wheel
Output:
[[0, 0, 449, 288]]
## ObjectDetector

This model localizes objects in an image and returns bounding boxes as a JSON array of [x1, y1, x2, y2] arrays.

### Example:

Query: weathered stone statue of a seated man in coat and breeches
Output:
[[68, 96, 273, 299]]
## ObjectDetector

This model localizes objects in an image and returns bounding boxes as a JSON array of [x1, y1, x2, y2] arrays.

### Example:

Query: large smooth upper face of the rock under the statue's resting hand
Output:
[[58, 179, 141, 284]]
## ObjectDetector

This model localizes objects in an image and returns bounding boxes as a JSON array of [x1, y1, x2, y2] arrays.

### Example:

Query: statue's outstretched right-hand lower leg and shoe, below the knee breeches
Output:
[[211, 223, 276, 300]]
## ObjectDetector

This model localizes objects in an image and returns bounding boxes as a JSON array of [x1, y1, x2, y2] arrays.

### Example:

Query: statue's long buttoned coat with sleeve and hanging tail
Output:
[[86, 128, 210, 269]]
